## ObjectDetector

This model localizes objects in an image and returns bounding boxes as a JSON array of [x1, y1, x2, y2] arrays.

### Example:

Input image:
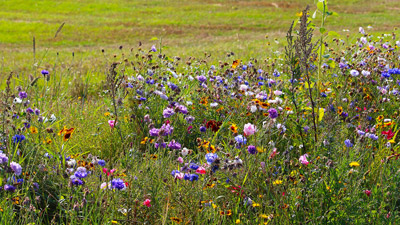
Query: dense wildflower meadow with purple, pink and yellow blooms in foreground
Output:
[[0, 0, 400, 225]]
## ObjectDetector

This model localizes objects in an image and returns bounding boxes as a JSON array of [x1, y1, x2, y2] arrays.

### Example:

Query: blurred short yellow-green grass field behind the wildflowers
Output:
[[0, 0, 400, 56]]
